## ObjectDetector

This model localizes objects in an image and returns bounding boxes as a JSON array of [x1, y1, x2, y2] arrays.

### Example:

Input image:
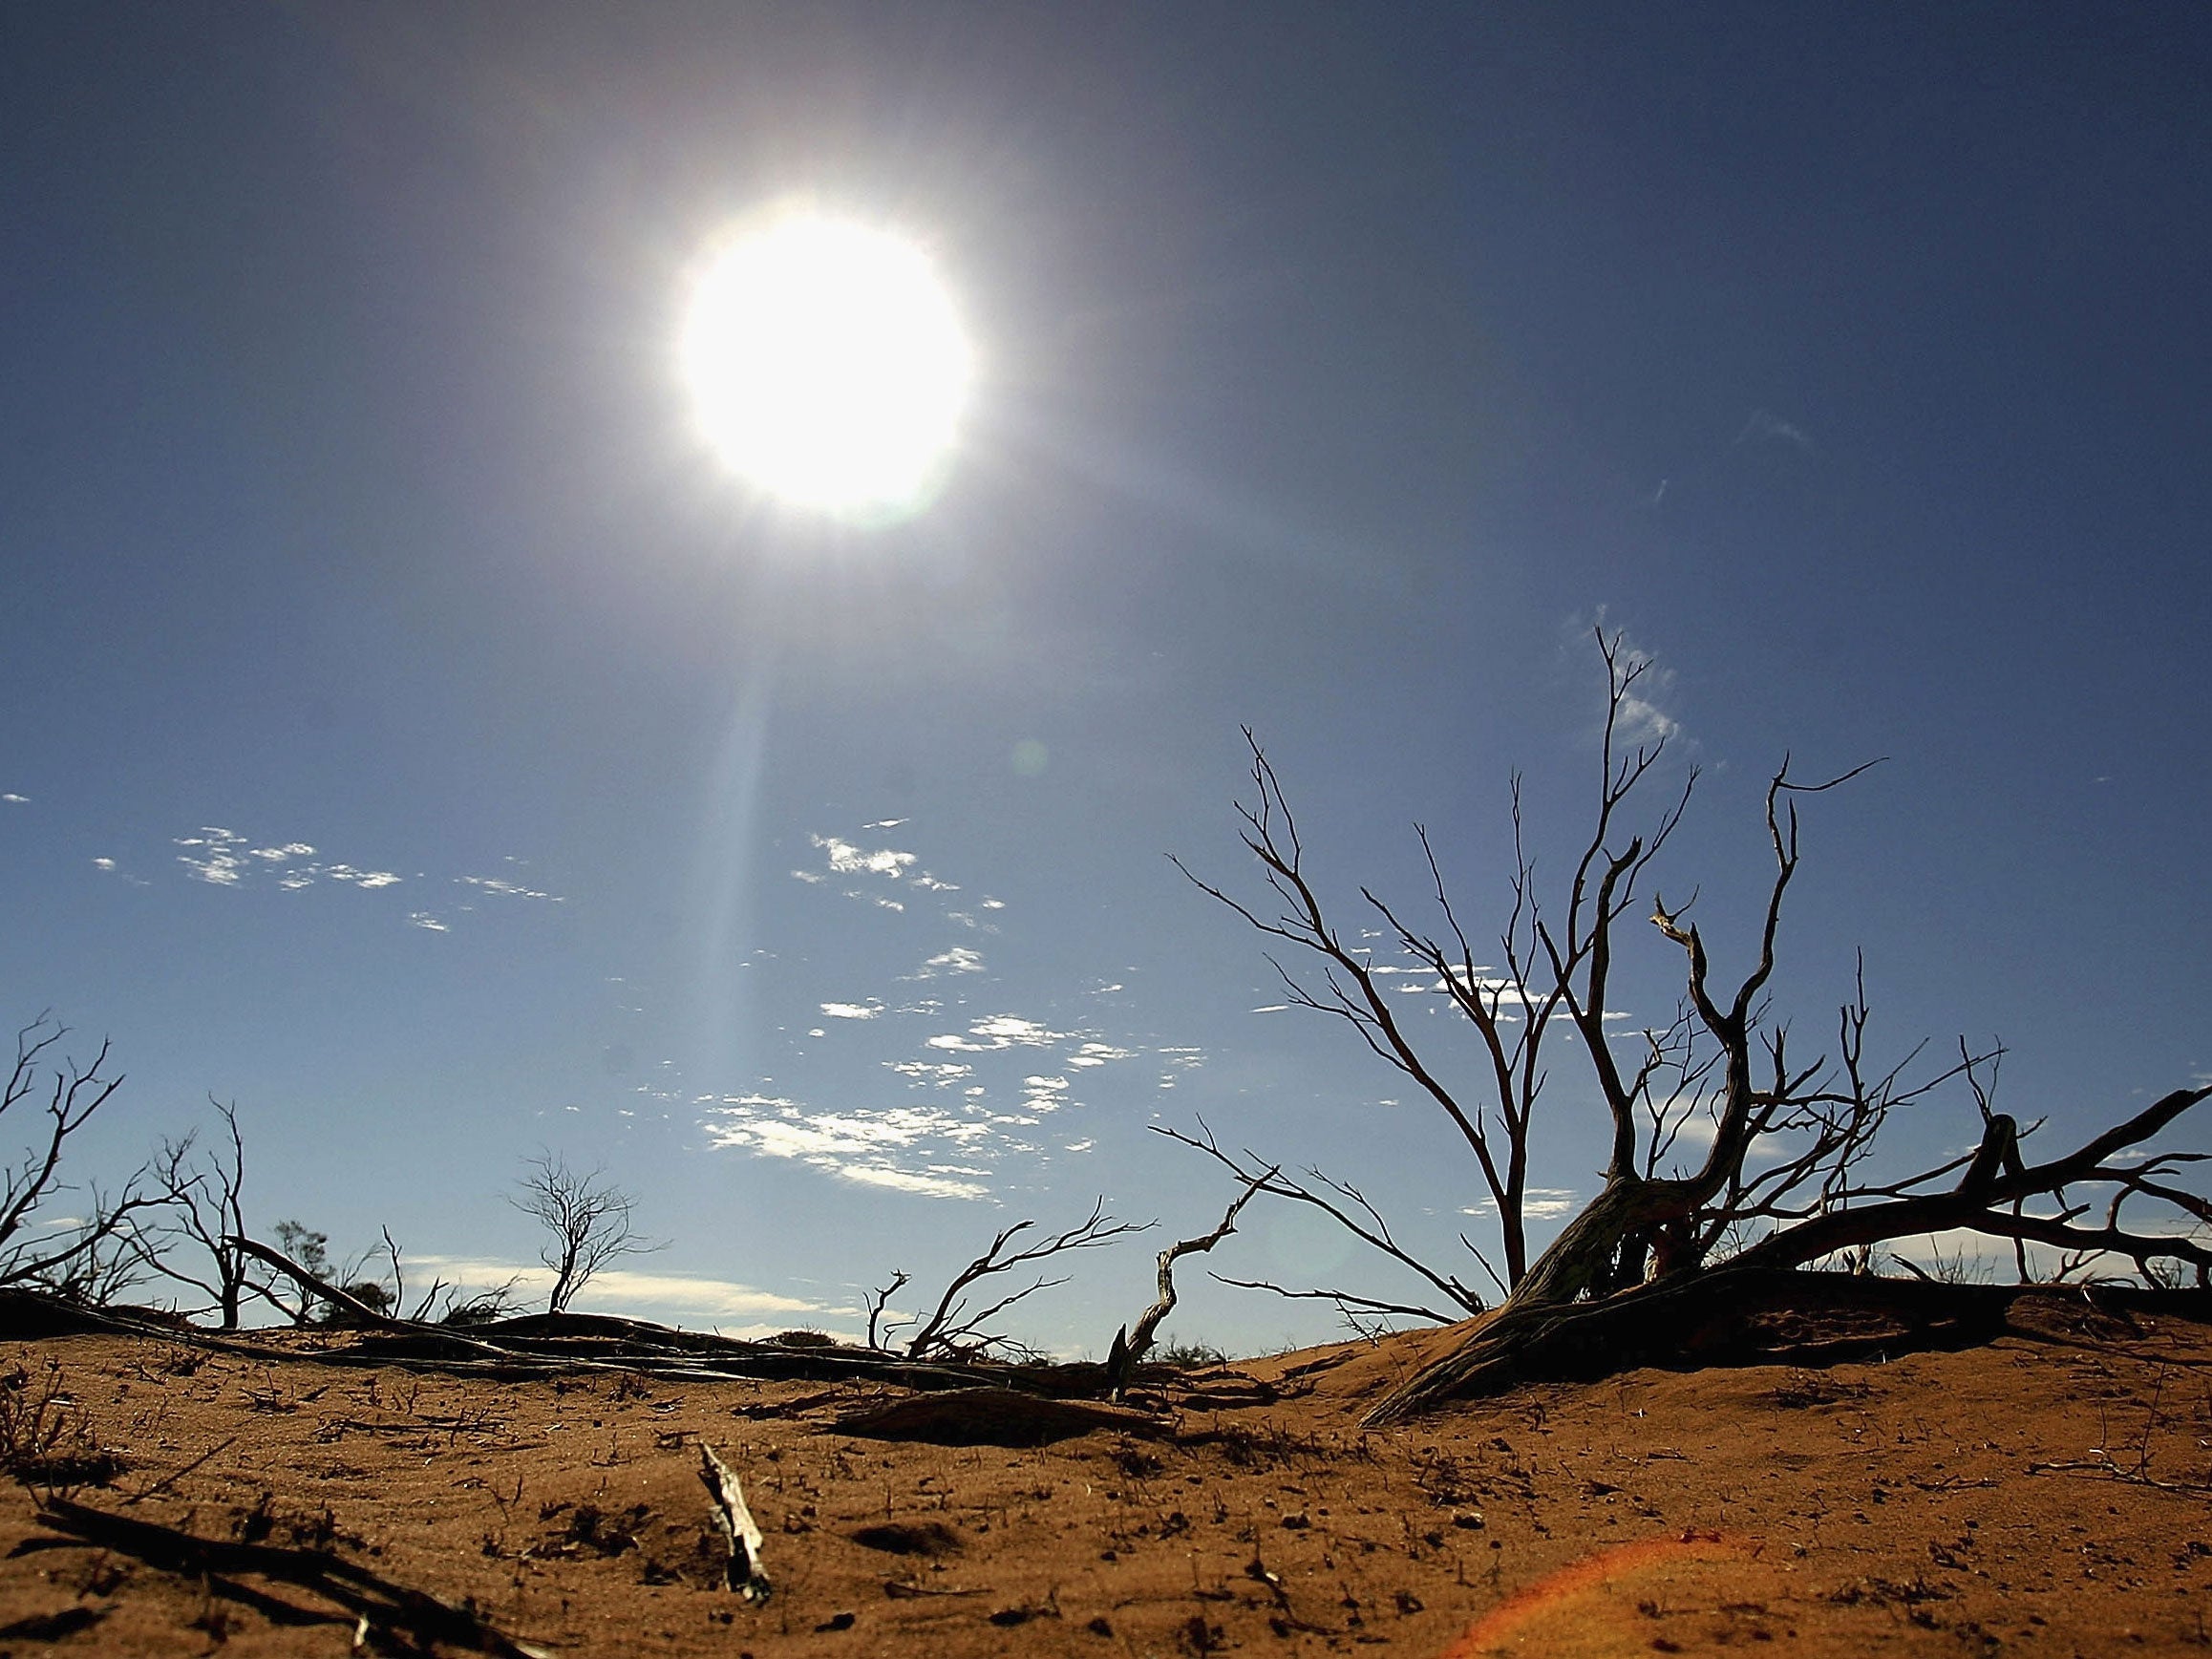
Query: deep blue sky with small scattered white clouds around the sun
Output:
[[0, 5, 2212, 1350]]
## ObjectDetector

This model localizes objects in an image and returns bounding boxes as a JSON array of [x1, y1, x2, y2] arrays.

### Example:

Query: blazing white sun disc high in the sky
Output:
[[684, 217, 973, 522]]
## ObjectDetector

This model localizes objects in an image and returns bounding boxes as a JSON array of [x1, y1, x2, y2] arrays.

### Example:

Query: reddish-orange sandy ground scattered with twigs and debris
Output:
[[0, 1296, 2212, 1659]]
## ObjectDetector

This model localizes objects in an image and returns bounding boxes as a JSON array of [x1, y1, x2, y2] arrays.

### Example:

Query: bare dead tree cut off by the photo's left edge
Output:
[[0, 1015, 161, 1303]]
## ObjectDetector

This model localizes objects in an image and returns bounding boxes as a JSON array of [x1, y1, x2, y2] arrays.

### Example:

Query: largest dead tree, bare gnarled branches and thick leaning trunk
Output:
[[1177, 635, 2212, 1422]]
